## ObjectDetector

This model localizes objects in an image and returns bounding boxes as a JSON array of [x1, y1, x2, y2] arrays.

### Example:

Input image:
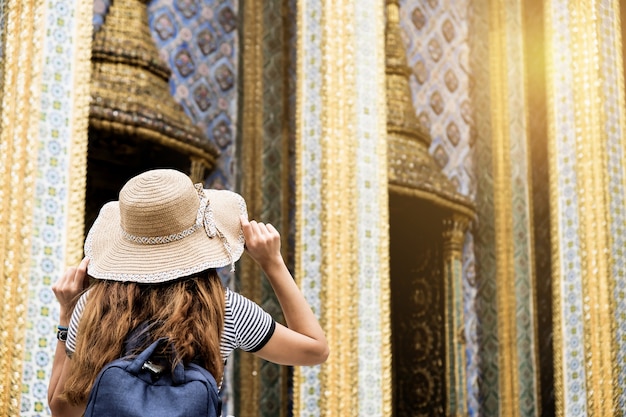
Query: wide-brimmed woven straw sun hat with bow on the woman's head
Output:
[[85, 169, 247, 283]]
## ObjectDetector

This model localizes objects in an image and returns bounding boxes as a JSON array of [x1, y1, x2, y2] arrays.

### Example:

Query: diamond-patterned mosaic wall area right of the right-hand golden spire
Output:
[[400, 0, 476, 197]]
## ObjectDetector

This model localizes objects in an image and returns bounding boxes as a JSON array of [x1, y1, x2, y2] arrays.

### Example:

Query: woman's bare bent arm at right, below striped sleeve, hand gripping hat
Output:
[[241, 217, 329, 365]]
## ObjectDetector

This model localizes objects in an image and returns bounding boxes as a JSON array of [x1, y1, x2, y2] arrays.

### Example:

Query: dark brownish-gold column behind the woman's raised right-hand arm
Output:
[[238, 0, 295, 417]]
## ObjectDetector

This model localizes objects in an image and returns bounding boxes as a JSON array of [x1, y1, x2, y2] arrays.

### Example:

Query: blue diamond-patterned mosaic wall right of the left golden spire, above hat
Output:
[[148, 0, 238, 189]]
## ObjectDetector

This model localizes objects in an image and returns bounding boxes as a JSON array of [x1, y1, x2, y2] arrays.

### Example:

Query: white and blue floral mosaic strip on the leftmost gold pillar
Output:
[[21, 0, 76, 416]]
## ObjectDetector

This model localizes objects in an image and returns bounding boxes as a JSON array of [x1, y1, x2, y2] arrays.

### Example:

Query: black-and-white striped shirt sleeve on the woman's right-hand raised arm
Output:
[[222, 289, 276, 356]]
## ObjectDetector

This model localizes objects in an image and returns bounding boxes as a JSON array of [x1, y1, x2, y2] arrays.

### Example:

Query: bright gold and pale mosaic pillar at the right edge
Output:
[[545, 0, 626, 416]]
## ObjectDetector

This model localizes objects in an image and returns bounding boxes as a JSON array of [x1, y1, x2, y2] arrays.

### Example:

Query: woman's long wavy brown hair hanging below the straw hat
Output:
[[64, 270, 225, 404]]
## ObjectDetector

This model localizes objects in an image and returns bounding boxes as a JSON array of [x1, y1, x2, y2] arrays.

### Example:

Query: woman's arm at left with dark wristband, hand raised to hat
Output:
[[48, 258, 89, 417]]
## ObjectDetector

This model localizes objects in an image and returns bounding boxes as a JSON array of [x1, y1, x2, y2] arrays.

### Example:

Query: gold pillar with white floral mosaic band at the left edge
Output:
[[0, 0, 93, 416]]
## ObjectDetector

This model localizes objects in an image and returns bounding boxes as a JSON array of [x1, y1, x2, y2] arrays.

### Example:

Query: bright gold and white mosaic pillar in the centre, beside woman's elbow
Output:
[[294, 0, 391, 416]]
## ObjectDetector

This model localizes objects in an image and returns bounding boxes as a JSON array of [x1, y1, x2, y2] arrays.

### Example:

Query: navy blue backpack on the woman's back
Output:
[[85, 338, 221, 417]]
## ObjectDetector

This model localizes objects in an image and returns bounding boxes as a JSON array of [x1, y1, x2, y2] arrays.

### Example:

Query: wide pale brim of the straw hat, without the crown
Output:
[[85, 190, 247, 283]]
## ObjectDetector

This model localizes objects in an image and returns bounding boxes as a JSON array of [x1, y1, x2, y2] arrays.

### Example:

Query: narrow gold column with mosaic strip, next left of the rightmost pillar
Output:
[[489, 0, 541, 417]]
